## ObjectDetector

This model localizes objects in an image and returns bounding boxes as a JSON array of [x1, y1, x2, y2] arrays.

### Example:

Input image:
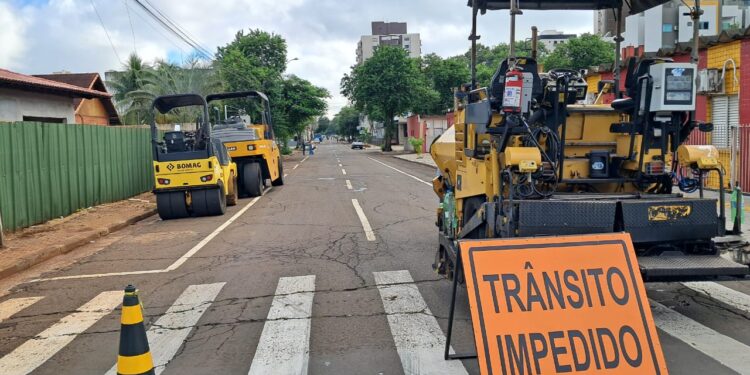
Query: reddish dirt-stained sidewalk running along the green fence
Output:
[[0, 193, 156, 279]]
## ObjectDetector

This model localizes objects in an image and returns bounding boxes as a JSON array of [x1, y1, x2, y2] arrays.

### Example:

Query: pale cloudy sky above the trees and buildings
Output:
[[0, 0, 593, 115]]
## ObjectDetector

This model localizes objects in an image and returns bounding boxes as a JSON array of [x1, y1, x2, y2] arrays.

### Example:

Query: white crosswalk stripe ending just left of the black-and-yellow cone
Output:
[[0, 291, 122, 375]]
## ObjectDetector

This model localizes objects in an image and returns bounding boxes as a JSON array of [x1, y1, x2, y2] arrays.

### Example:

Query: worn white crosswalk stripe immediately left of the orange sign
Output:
[[373, 271, 468, 374]]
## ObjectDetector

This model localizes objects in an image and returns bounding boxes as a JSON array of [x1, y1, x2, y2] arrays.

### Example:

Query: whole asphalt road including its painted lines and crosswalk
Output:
[[0, 144, 750, 375]]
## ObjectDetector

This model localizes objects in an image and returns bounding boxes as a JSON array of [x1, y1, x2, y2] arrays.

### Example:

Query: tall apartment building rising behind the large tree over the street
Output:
[[357, 22, 422, 64]]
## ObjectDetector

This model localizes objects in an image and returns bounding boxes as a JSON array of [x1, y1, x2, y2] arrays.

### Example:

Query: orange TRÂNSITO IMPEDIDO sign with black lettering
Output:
[[460, 233, 667, 375]]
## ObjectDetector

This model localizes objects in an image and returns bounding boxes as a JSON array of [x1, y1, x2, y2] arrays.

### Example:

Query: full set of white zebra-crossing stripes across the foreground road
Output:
[[0, 278, 750, 375]]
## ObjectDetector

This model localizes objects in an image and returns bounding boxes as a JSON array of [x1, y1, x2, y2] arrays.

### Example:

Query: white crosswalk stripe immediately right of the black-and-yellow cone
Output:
[[106, 283, 226, 375]]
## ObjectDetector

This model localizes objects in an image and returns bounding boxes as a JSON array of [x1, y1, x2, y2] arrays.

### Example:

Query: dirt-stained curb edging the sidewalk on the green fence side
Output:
[[0, 208, 156, 279]]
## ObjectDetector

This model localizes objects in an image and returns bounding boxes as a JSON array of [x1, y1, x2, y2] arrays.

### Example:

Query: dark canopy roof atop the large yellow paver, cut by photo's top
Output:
[[468, 0, 669, 14]]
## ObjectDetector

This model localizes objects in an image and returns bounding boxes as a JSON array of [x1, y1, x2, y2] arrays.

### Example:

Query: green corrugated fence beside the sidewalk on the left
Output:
[[0, 122, 153, 230]]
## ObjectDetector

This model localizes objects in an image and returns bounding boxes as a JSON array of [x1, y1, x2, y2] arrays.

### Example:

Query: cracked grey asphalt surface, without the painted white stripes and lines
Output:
[[0, 144, 750, 374]]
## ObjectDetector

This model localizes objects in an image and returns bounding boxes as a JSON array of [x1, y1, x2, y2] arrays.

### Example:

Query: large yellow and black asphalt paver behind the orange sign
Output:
[[431, 0, 748, 280]]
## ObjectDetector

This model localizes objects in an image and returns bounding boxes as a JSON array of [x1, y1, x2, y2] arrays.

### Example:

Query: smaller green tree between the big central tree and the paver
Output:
[[422, 53, 471, 115]]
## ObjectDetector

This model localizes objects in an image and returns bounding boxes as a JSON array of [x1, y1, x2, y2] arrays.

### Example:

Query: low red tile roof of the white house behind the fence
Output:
[[0, 69, 112, 99]]
